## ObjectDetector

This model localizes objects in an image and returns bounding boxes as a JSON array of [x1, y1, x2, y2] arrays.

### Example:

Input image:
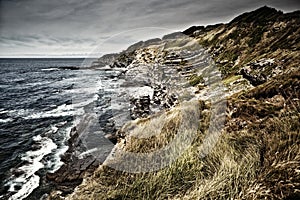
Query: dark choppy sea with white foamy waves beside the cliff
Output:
[[0, 59, 101, 199]]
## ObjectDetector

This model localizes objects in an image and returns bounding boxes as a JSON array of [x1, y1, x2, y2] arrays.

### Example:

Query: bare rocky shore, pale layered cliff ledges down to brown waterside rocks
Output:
[[46, 33, 216, 196]]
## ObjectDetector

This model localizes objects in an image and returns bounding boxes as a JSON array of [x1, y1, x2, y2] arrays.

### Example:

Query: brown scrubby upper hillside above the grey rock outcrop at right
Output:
[[191, 7, 300, 78]]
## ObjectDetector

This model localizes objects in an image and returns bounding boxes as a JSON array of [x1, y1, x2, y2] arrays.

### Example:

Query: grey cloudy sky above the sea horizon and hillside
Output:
[[0, 0, 300, 57]]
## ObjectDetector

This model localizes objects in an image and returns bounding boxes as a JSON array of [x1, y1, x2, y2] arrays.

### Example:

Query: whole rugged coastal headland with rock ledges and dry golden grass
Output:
[[50, 7, 300, 199]]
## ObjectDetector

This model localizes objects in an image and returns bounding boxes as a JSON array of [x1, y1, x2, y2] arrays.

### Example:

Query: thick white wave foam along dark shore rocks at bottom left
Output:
[[6, 135, 57, 200]]
